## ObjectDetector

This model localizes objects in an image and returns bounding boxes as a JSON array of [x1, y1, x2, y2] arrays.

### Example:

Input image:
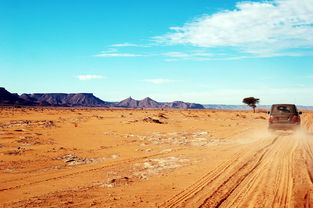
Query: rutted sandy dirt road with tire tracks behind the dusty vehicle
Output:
[[163, 133, 313, 207]]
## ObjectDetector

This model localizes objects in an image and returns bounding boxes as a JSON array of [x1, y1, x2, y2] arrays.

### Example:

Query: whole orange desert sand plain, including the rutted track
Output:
[[0, 108, 313, 207]]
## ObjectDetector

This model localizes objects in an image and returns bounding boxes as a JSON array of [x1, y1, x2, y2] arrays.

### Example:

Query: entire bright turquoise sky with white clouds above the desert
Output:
[[0, 0, 313, 105]]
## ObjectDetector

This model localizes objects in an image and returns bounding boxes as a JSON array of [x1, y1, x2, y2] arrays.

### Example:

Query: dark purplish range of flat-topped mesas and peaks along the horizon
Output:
[[0, 88, 204, 109]]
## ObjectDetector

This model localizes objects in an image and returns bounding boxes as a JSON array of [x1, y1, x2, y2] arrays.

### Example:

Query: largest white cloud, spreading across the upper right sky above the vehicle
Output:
[[157, 0, 313, 56]]
